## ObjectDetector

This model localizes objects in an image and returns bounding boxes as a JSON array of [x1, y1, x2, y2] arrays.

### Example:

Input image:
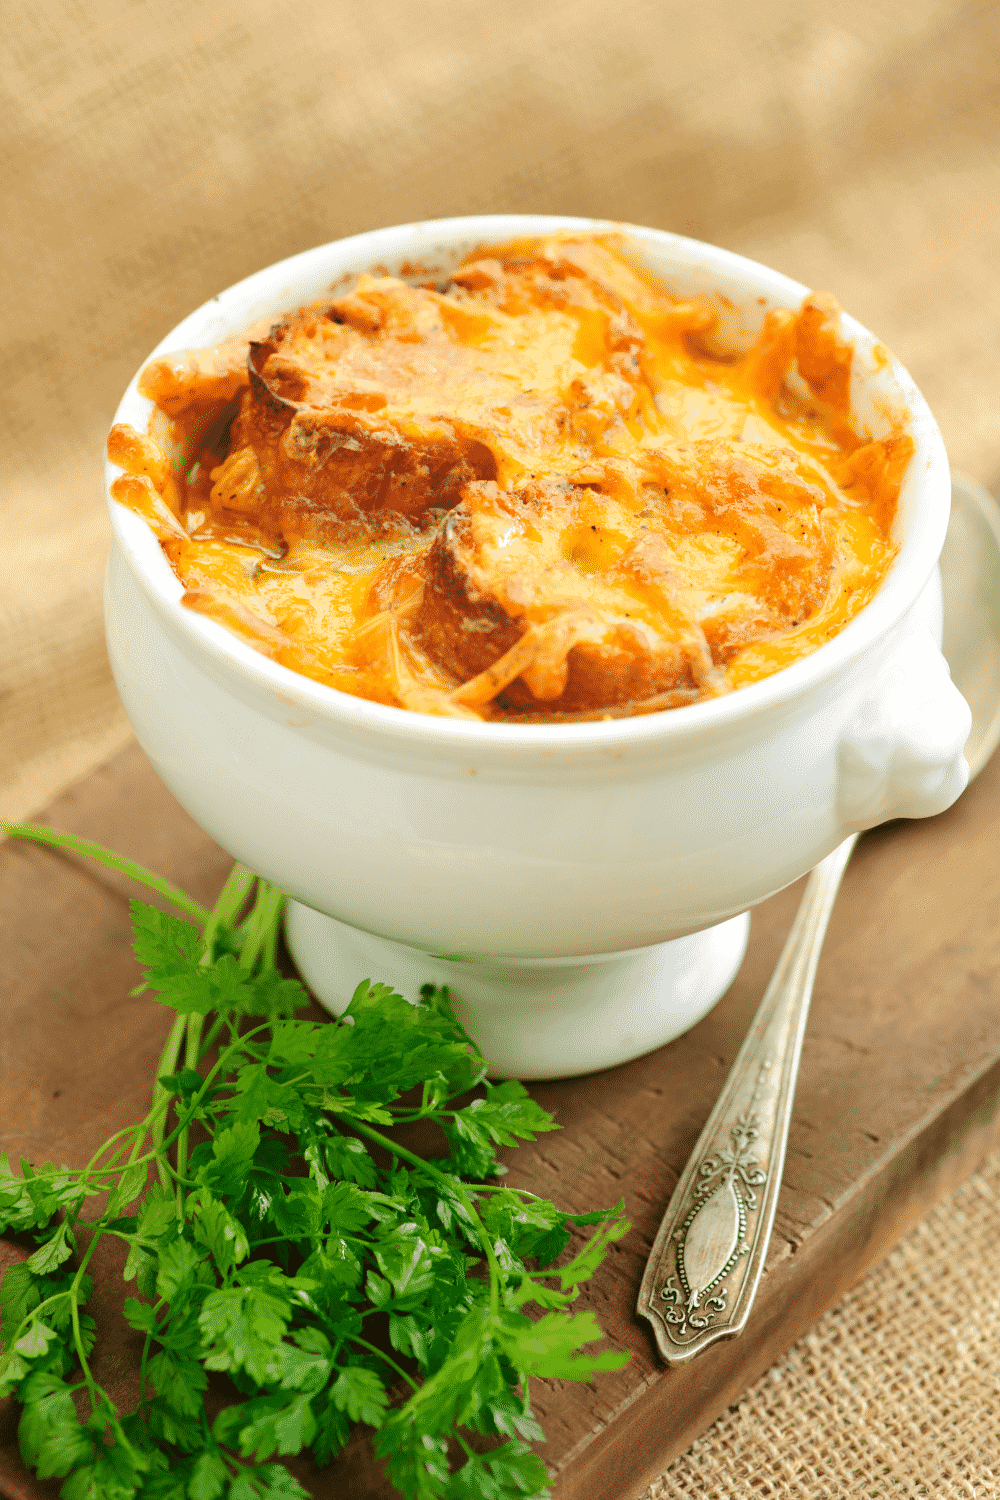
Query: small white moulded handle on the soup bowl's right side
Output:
[[837, 627, 972, 834]]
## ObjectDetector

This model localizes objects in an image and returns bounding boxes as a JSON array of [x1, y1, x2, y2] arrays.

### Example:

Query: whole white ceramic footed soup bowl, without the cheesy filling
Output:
[[106, 216, 970, 1077]]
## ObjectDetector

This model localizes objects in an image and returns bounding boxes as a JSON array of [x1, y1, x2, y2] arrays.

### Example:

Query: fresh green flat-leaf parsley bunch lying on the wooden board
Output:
[[0, 827, 628, 1500]]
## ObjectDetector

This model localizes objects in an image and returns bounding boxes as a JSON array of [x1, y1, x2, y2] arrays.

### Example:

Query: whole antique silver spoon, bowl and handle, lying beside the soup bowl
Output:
[[639, 474, 1000, 1365]]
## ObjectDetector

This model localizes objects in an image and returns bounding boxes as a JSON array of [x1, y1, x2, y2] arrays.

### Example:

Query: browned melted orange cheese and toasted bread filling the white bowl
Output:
[[108, 236, 913, 720]]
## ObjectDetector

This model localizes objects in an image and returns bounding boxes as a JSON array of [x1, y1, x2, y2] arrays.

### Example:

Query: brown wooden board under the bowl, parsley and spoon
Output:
[[0, 749, 1000, 1500]]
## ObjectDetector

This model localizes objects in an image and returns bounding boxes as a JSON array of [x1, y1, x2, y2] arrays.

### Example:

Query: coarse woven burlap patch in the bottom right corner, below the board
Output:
[[650, 1155, 1000, 1500]]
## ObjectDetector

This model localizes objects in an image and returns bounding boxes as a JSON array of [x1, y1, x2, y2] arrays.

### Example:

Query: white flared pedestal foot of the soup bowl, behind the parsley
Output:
[[285, 902, 750, 1079]]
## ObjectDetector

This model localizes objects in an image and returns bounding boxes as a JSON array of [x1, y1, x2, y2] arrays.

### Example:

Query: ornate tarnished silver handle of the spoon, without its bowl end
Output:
[[639, 834, 858, 1365]]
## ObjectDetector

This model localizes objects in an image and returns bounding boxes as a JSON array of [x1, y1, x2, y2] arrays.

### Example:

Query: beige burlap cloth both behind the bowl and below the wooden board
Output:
[[0, 0, 1000, 1500]]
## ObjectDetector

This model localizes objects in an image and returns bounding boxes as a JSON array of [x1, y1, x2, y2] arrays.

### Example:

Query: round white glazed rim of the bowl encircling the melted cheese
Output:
[[105, 215, 951, 756]]
